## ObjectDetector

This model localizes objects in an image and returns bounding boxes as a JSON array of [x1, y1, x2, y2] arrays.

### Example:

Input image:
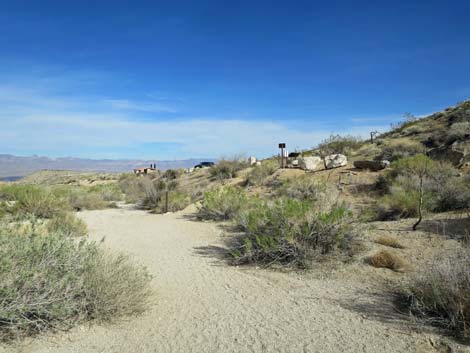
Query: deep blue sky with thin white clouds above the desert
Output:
[[0, 0, 470, 159]]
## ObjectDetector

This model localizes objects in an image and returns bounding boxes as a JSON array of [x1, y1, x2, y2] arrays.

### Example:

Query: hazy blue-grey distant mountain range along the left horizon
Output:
[[0, 154, 214, 179]]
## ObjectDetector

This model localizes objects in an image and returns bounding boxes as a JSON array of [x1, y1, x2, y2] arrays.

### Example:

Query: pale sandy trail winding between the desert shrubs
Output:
[[7, 209, 433, 353]]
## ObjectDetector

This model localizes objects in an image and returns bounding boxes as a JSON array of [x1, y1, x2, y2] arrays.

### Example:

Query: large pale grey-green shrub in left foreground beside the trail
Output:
[[0, 227, 151, 340]]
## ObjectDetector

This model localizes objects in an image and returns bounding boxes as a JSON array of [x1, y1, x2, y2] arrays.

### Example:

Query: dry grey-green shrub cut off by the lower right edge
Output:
[[398, 249, 470, 339]]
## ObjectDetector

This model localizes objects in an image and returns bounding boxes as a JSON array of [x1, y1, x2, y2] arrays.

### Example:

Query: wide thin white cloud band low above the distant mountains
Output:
[[0, 73, 388, 159]]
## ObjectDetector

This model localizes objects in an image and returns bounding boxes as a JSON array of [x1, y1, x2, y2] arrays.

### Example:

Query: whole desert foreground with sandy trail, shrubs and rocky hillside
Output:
[[0, 101, 470, 352]]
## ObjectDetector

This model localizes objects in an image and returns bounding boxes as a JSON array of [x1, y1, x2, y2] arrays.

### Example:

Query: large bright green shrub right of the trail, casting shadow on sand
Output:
[[232, 198, 350, 268]]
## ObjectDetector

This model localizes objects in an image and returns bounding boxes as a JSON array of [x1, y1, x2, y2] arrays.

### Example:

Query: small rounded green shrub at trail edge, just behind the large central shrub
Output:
[[198, 186, 248, 220]]
